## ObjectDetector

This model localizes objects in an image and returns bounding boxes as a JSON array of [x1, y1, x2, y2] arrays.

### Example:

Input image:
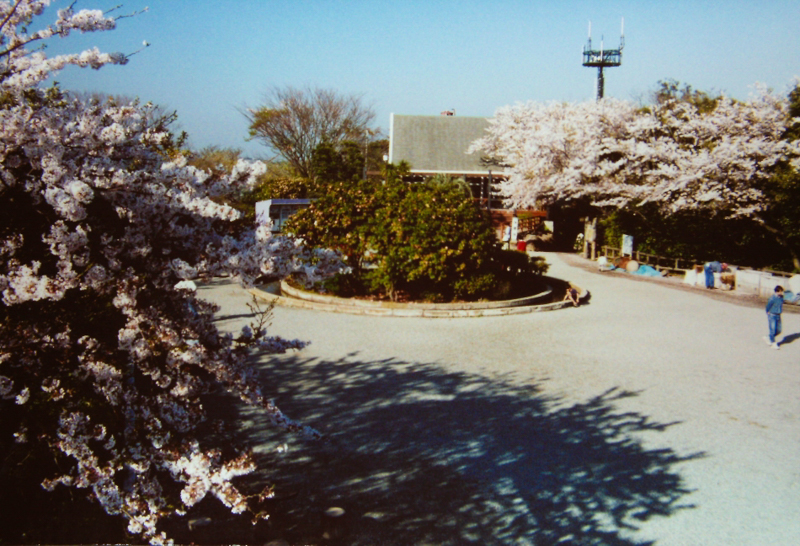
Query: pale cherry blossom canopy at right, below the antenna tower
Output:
[[470, 86, 800, 218]]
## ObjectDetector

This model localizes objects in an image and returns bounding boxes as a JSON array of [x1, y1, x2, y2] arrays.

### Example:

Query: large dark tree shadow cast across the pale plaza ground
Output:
[[172, 355, 703, 545]]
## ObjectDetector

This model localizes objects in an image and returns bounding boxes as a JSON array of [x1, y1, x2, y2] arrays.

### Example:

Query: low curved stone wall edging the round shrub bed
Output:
[[250, 282, 585, 318]]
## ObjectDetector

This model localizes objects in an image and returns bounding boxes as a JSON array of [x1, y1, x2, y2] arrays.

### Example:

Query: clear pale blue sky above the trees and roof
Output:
[[45, 0, 800, 157]]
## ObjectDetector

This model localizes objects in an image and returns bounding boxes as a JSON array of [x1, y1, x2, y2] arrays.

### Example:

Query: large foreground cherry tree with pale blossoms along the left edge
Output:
[[0, 0, 341, 543]]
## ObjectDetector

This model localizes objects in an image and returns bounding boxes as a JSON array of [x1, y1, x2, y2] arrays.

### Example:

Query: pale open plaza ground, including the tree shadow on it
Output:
[[199, 253, 800, 546]]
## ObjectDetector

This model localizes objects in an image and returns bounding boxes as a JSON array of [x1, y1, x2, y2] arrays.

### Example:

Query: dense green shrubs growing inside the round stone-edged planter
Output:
[[286, 169, 560, 302]]
